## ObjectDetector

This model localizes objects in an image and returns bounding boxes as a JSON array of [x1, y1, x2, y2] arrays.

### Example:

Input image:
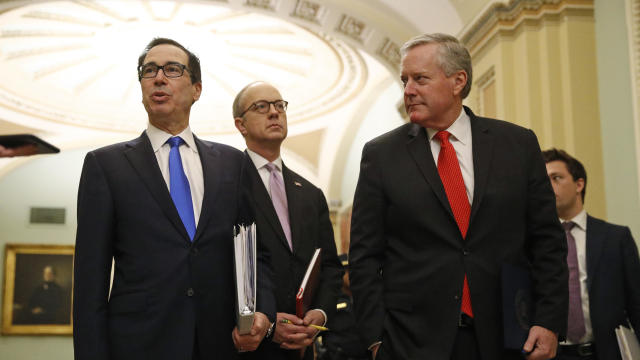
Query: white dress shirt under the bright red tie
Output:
[[427, 108, 474, 204]]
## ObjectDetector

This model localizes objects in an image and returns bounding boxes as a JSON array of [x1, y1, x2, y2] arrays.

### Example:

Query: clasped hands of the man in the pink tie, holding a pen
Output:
[[273, 310, 316, 350]]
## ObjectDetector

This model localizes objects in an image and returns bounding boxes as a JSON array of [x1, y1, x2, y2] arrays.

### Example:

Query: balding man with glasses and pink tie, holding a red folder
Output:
[[233, 82, 342, 360]]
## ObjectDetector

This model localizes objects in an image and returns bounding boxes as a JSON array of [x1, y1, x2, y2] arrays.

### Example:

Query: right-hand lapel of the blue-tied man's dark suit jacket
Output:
[[193, 135, 224, 243]]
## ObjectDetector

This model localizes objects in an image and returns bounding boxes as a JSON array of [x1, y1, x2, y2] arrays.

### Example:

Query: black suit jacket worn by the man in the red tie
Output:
[[349, 107, 568, 360]]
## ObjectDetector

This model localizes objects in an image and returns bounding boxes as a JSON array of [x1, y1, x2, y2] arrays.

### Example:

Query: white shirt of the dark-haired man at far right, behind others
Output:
[[560, 210, 593, 345]]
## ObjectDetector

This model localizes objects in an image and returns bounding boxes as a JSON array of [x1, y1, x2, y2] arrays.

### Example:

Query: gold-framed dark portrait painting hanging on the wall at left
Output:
[[2, 244, 74, 335]]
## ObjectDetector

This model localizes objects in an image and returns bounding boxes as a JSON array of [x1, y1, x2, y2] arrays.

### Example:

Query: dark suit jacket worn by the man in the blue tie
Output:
[[73, 133, 275, 360]]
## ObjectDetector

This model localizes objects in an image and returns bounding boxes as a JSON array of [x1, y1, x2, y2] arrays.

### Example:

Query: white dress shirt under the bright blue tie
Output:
[[147, 123, 204, 227]]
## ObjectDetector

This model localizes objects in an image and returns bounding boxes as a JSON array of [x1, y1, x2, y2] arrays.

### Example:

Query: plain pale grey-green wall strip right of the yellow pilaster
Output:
[[595, 0, 640, 236]]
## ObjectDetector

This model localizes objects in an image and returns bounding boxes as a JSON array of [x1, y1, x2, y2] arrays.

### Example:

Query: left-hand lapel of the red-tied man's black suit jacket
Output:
[[407, 124, 457, 219]]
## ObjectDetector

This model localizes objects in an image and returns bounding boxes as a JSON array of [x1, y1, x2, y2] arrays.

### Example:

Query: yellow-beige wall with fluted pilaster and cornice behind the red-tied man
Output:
[[467, 1, 607, 218]]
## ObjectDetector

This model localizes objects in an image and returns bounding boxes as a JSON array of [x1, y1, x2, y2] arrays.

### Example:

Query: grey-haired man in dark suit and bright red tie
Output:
[[349, 34, 567, 360]]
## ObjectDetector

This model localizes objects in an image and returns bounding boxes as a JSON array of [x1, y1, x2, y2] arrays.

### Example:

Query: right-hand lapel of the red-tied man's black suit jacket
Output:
[[465, 107, 493, 227]]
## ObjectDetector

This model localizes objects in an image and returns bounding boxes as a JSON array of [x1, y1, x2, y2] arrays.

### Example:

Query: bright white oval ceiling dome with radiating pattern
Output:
[[0, 1, 366, 135]]
